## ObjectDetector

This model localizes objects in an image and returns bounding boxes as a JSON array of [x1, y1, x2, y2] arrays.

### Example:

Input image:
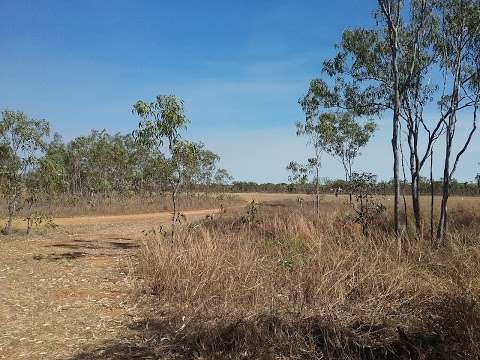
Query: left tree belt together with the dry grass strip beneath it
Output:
[[0, 105, 230, 234]]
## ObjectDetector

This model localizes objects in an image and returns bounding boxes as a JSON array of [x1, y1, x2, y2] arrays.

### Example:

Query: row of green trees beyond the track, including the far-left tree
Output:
[[0, 110, 231, 234]]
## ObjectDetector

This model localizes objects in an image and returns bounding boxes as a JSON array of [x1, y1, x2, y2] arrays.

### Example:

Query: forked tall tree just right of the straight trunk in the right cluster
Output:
[[392, 0, 445, 234]]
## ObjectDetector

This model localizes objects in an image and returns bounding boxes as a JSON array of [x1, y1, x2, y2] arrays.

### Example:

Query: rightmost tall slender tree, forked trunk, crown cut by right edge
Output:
[[436, 0, 480, 243]]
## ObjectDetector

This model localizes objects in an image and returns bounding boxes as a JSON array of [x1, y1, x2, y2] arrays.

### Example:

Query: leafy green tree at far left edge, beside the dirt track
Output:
[[0, 110, 50, 234]]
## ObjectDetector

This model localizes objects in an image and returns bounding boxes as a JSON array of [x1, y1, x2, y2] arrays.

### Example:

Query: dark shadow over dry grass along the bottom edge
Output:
[[65, 316, 450, 360]]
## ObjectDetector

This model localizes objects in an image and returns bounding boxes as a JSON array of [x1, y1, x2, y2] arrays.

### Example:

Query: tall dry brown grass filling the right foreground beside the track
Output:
[[134, 200, 480, 359]]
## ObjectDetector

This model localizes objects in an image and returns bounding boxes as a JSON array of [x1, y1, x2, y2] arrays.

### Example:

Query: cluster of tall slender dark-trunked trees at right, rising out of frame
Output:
[[330, 0, 480, 239]]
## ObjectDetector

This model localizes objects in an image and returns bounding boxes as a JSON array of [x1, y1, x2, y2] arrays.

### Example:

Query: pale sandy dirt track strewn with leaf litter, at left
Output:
[[0, 210, 225, 360]]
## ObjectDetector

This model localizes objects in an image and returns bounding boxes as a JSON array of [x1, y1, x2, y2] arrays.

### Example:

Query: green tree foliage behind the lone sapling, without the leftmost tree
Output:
[[24, 130, 229, 196]]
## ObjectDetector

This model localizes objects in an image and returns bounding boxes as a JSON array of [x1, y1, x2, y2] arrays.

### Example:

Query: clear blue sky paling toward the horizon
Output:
[[0, 0, 480, 182]]
